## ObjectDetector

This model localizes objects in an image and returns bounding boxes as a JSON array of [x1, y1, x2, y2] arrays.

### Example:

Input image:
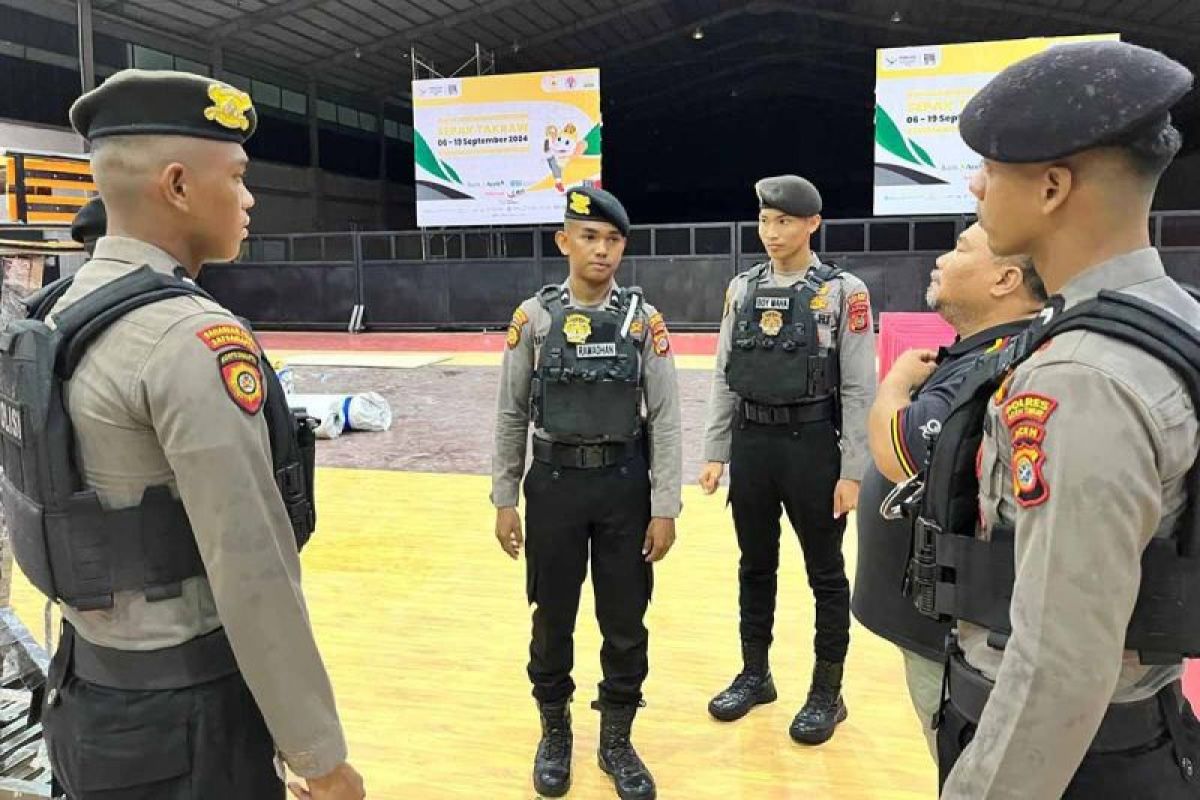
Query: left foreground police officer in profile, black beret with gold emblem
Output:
[[16, 70, 364, 800]]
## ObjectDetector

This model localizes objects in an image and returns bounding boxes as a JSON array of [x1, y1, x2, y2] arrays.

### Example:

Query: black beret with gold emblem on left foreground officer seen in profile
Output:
[[71, 70, 258, 144]]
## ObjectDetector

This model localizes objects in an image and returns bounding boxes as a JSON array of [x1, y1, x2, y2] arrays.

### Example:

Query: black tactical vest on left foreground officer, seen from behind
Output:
[[0, 266, 316, 610]]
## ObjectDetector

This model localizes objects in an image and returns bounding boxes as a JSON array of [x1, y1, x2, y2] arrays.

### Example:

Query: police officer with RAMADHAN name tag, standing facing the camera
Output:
[[492, 187, 682, 800]]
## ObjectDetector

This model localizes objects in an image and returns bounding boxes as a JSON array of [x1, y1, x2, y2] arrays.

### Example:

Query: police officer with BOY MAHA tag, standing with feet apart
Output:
[[700, 175, 875, 745]]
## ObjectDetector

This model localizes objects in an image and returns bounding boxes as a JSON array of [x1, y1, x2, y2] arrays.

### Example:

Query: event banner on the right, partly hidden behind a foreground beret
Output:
[[875, 34, 1120, 216]]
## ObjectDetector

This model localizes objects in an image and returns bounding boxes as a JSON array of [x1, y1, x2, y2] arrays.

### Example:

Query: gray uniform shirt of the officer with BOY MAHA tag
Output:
[[704, 253, 876, 481]]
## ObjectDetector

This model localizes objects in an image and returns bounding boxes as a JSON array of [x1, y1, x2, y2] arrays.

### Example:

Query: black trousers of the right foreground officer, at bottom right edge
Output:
[[937, 686, 1200, 800]]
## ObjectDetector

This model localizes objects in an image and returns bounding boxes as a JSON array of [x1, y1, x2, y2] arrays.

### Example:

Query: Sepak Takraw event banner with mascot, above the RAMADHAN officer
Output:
[[413, 70, 600, 228]]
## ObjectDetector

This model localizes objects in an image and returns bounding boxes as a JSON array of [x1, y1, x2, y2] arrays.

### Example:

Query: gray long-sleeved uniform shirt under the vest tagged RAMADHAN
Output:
[[492, 283, 683, 519]]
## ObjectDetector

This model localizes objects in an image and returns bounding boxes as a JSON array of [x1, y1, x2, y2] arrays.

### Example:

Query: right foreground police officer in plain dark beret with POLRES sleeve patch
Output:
[[926, 42, 1200, 800]]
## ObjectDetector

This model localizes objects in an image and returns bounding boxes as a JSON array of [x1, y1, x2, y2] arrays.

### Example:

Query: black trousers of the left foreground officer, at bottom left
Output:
[[42, 642, 286, 800]]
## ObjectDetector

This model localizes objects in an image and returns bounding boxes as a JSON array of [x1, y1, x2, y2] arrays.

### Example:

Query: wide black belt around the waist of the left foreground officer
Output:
[[54, 622, 238, 692]]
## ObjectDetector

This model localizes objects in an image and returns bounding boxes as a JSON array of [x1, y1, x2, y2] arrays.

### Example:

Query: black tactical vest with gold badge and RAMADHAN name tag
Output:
[[530, 285, 646, 441]]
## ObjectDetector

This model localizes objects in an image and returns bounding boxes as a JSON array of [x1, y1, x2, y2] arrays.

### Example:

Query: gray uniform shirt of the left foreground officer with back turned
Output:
[[48, 236, 346, 777]]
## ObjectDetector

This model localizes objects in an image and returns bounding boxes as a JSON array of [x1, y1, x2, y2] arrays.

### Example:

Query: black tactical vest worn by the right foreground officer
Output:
[[908, 291, 1200, 664]]
